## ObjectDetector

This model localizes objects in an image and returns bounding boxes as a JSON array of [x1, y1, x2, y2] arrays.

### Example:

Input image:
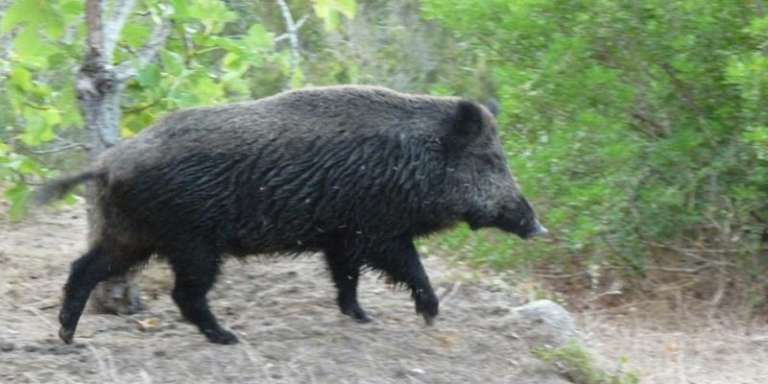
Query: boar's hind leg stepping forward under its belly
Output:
[[168, 249, 237, 344]]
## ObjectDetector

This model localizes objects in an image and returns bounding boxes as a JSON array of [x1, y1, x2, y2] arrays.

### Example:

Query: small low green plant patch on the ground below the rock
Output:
[[531, 341, 640, 384]]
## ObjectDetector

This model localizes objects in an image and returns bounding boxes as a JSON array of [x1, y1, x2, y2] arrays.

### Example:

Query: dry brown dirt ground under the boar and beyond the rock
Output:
[[0, 205, 768, 384]]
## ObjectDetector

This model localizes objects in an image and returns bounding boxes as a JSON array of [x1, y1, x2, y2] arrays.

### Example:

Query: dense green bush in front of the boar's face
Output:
[[422, 0, 768, 282]]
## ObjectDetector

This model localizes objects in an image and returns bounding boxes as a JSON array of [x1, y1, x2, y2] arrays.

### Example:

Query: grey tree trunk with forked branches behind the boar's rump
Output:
[[75, 0, 170, 314]]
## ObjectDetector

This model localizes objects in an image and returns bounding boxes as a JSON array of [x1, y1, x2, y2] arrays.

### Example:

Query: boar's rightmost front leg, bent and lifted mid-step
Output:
[[367, 238, 439, 325]]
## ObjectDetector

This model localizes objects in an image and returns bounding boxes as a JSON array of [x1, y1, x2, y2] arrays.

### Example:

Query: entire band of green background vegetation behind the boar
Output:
[[0, 0, 768, 308]]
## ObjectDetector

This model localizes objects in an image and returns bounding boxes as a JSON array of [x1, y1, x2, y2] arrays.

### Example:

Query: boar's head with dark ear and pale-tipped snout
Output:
[[442, 101, 548, 239]]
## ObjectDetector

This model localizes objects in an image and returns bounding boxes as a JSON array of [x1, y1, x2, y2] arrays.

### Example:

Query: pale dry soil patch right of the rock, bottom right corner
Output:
[[579, 303, 768, 384]]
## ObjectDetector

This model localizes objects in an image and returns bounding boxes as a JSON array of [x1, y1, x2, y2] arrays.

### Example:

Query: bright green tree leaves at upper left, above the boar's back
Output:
[[0, 0, 294, 219]]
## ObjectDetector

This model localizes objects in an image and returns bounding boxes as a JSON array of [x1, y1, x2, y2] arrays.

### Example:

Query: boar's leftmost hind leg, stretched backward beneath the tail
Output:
[[59, 244, 149, 344]]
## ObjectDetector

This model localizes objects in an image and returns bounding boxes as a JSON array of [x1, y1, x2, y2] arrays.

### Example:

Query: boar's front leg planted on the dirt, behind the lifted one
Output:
[[325, 247, 371, 323]]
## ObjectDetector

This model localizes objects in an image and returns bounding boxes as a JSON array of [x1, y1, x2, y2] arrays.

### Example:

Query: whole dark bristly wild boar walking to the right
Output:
[[43, 86, 538, 344]]
